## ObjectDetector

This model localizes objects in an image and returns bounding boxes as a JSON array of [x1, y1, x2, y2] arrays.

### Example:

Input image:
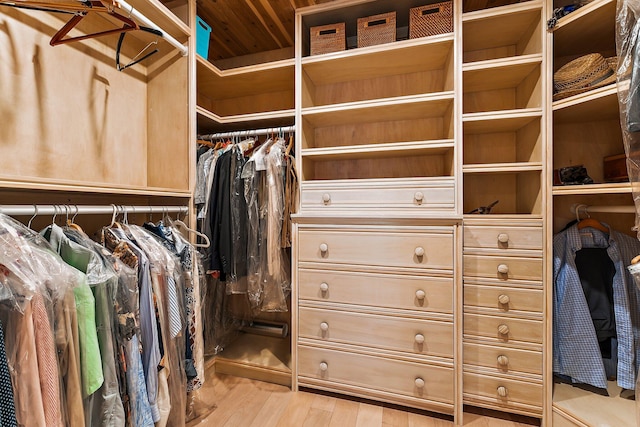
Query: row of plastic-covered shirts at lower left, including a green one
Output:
[[0, 215, 204, 427]]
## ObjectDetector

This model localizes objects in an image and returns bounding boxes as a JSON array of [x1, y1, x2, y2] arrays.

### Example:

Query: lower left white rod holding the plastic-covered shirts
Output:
[[0, 204, 189, 216]]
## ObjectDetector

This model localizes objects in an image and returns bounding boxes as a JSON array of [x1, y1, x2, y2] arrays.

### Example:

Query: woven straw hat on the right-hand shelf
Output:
[[553, 53, 617, 101]]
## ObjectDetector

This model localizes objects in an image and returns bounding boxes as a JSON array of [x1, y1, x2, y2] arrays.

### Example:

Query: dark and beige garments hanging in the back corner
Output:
[[194, 137, 298, 353]]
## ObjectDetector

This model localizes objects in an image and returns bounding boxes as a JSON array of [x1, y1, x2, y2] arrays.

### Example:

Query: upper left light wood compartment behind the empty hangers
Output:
[[0, 0, 194, 224]]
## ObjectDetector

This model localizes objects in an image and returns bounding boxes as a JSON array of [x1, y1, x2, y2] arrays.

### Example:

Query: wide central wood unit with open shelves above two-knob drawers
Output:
[[293, 0, 462, 417]]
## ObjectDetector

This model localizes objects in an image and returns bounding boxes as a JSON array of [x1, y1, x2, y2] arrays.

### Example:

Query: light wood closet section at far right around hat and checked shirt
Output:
[[546, 0, 637, 426]]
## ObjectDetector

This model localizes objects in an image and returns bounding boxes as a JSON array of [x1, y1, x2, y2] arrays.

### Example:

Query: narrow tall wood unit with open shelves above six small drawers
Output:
[[460, 1, 548, 418]]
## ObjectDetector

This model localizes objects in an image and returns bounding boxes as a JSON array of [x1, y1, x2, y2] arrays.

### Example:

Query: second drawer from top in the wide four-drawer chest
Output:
[[298, 269, 453, 314]]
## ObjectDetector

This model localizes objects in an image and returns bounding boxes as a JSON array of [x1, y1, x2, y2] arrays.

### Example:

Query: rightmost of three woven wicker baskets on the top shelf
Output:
[[409, 1, 453, 39]]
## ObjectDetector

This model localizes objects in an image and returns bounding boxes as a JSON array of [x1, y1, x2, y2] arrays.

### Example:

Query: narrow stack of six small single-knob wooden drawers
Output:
[[463, 219, 545, 416]]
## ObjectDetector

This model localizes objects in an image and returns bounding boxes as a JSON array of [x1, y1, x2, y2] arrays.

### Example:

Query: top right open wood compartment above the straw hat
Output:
[[553, 0, 616, 65]]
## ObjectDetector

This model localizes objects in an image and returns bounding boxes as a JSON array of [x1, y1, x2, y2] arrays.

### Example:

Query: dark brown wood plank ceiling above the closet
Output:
[[196, 0, 510, 61]]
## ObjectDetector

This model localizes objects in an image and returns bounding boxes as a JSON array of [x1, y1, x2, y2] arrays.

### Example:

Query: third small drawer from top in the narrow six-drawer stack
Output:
[[464, 283, 544, 313]]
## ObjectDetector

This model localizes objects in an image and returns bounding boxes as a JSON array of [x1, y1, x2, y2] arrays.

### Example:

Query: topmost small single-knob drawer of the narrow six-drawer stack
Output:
[[464, 225, 543, 251]]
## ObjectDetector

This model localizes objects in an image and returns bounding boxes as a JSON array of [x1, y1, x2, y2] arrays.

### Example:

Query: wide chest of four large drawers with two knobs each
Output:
[[296, 220, 458, 414]]
